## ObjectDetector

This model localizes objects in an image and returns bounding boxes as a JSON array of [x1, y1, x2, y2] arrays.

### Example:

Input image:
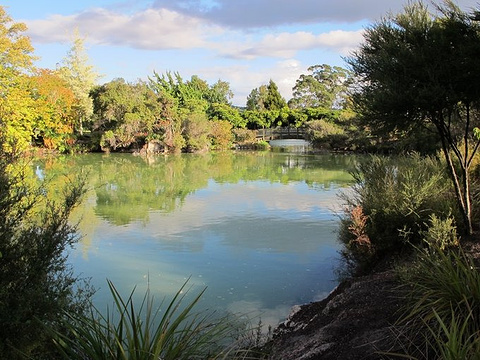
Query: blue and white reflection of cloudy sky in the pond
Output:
[[71, 177, 344, 325]]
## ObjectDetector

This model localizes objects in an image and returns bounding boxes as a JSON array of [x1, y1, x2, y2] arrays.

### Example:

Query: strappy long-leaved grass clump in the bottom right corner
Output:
[[399, 245, 480, 359]]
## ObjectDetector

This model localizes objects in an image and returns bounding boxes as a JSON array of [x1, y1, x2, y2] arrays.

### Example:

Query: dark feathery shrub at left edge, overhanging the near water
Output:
[[0, 147, 89, 359]]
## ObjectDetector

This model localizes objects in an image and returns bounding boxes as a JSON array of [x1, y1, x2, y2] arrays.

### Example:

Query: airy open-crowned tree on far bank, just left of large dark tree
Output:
[[289, 64, 351, 109]]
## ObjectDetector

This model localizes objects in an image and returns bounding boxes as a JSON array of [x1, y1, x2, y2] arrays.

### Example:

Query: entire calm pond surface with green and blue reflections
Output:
[[35, 152, 356, 325]]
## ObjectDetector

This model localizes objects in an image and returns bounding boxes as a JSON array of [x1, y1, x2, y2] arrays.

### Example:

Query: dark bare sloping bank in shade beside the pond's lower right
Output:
[[268, 270, 401, 360]]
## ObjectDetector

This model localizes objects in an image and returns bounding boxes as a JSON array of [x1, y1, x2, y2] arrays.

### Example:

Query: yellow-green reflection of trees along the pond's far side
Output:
[[36, 152, 356, 225]]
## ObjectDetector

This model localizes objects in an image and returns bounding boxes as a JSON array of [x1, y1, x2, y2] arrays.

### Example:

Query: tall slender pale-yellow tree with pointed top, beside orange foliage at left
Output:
[[59, 31, 99, 135]]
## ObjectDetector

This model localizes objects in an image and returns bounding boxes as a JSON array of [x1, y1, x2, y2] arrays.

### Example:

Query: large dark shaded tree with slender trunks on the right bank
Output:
[[347, 1, 480, 234]]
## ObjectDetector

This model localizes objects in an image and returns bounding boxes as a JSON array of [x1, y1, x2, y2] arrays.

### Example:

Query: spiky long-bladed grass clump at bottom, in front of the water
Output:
[[51, 281, 255, 360]]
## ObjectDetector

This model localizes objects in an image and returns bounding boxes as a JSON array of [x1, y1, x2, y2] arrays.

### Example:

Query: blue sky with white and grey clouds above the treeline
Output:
[[0, 0, 480, 106]]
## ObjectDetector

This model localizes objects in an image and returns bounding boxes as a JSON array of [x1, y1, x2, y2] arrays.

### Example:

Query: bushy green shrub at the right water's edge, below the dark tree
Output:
[[339, 154, 456, 271]]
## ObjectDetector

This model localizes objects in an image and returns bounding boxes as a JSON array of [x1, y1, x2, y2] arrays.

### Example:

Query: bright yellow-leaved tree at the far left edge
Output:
[[0, 6, 35, 152]]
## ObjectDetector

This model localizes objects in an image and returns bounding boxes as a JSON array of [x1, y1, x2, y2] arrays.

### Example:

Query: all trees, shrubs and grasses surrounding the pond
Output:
[[0, 1, 480, 359]]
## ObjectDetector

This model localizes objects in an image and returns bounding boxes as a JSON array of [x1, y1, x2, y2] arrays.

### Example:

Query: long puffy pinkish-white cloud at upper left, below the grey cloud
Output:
[[26, 8, 221, 50]]
